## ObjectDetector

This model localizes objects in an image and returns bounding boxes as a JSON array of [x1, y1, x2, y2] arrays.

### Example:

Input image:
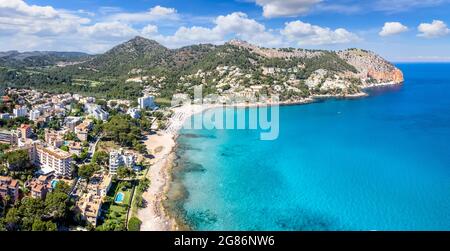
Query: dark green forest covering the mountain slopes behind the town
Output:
[[0, 37, 364, 101]]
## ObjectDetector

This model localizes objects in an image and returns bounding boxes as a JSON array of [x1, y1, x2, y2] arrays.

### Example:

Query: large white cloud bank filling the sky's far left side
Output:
[[0, 0, 177, 53]]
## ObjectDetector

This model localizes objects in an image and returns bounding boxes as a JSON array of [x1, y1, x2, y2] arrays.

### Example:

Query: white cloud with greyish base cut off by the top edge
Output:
[[255, 0, 322, 18]]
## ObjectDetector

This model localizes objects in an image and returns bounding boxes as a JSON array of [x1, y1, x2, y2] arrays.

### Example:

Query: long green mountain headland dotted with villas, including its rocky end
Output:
[[0, 37, 403, 101]]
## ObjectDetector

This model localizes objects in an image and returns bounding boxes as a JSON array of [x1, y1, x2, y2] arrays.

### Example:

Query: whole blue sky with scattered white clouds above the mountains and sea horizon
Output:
[[0, 0, 450, 62]]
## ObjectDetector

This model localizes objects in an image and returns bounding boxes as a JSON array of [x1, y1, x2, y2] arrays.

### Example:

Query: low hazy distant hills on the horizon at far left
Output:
[[0, 51, 91, 67]]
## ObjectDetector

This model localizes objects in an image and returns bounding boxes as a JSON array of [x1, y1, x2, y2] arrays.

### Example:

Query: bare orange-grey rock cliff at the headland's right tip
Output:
[[337, 49, 404, 84]]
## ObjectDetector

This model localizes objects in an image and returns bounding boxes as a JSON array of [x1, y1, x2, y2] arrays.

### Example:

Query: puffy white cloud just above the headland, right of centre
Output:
[[281, 21, 360, 45]]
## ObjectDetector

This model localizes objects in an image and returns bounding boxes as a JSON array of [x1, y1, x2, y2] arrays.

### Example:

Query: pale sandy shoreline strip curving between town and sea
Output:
[[137, 82, 402, 231]]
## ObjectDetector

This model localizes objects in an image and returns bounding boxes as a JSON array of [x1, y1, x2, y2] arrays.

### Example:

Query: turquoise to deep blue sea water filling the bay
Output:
[[178, 64, 450, 230]]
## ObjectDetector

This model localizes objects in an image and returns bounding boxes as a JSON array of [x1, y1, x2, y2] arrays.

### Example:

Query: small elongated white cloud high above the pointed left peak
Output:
[[107, 5, 178, 23]]
